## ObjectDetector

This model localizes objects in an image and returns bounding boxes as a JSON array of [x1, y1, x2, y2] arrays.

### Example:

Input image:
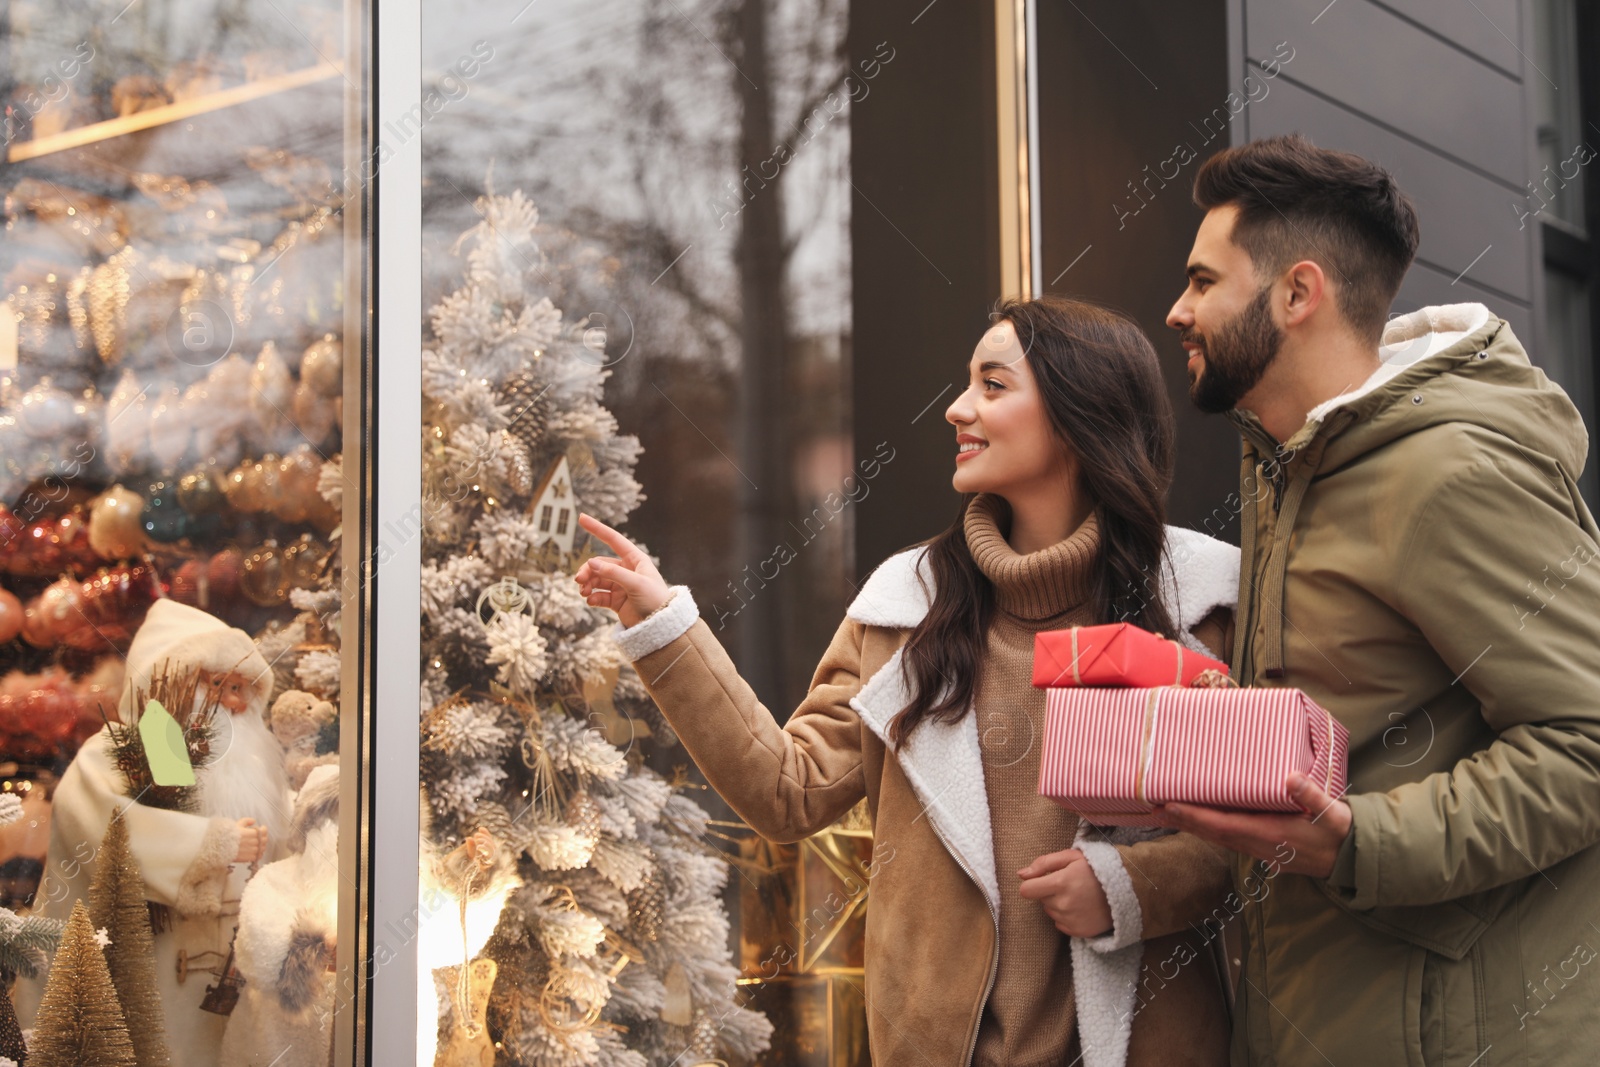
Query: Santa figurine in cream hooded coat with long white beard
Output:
[[18, 600, 291, 1065]]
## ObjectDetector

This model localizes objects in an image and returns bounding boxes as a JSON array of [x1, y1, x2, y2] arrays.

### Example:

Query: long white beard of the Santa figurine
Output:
[[195, 710, 290, 851]]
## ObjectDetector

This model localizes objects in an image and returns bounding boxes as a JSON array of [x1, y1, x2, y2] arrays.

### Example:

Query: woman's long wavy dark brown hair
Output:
[[890, 296, 1174, 744]]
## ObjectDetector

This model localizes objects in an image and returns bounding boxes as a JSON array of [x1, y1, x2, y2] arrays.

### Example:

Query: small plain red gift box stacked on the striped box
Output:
[[1034, 622, 1227, 689]]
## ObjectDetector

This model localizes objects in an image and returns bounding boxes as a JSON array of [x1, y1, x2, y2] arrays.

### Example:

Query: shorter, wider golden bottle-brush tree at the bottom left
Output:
[[27, 901, 138, 1067]]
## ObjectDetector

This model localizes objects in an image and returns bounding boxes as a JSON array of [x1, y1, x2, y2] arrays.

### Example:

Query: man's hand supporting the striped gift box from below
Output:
[[1155, 771, 1350, 878]]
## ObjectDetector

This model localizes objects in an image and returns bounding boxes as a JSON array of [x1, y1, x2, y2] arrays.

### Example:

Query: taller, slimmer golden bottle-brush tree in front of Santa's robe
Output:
[[90, 817, 171, 1067]]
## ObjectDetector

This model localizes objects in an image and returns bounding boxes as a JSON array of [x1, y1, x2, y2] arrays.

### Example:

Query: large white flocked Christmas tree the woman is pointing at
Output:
[[409, 192, 771, 1067]]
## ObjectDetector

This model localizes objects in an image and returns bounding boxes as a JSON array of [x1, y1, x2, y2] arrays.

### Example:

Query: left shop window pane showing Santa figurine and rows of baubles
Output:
[[0, 0, 366, 1065]]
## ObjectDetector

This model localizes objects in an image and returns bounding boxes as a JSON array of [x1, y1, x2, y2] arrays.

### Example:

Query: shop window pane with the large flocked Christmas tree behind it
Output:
[[418, 0, 872, 1067]]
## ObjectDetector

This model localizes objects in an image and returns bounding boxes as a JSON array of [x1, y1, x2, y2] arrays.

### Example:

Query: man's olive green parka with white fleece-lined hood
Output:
[[1227, 304, 1600, 1067]]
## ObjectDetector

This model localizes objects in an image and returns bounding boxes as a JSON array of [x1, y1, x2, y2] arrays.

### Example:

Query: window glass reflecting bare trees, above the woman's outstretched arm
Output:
[[424, 0, 850, 709]]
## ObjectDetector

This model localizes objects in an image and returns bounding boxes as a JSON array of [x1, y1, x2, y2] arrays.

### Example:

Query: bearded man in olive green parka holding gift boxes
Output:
[[1163, 138, 1600, 1067]]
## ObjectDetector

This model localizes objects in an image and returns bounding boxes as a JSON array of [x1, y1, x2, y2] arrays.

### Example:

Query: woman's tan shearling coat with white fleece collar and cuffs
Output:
[[618, 530, 1238, 1067]]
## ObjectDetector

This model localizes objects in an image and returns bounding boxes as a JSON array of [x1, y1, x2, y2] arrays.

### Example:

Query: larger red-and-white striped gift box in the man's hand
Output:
[[1038, 686, 1350, 825]]
